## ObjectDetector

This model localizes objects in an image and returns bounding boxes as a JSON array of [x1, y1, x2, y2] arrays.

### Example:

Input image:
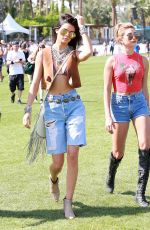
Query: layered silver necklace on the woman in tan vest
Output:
[[52, 44, 72, 66]]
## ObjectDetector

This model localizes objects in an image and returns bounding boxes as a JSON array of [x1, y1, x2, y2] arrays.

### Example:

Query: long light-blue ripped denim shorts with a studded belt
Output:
[[44, 90, 86, 154]]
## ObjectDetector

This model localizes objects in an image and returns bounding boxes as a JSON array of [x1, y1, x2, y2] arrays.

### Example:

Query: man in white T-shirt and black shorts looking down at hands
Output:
[[7, 41, 25, 104]]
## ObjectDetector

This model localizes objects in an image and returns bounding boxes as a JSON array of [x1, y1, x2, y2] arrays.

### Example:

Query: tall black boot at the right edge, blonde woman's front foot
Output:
[[135, 149, 150, 207]]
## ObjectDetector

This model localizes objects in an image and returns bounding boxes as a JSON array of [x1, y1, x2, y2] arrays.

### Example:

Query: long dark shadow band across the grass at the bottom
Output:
[[0, 202, 150, 226]]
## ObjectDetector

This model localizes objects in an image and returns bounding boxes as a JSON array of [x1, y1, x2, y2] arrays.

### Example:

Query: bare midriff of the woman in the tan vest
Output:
[[49, 75, 73, 95]]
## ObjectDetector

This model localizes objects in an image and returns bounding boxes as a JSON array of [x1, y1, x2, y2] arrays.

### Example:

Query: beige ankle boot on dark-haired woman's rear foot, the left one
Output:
[[49, 177, 60, 202]]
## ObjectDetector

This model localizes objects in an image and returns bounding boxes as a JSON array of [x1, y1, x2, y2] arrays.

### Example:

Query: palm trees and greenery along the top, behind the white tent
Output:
[[0, 0, 150, 34]]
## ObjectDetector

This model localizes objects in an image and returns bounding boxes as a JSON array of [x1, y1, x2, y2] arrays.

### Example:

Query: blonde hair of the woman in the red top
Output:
[[114, 22, 134, 43]]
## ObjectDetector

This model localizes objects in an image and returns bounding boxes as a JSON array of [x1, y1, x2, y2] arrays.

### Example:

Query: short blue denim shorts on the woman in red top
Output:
[[111, 92, 150, 122]]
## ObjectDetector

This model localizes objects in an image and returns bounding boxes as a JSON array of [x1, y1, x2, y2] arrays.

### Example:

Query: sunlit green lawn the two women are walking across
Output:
[[0, 57, 150, 230]]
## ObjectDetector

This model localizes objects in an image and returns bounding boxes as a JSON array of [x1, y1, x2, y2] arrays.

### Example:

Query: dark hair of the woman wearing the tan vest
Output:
[[53, 14, 81, 50]]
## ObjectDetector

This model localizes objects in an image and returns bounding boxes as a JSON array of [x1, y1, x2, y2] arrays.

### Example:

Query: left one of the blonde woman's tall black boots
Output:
[[106, 153, 122, 193]]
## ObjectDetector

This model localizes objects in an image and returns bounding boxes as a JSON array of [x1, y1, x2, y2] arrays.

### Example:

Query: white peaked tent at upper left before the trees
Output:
[[0, 14, 29, 35]]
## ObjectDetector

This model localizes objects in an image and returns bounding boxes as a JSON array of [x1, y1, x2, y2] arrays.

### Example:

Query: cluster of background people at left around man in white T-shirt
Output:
[[0, 40, 45, 104]]
